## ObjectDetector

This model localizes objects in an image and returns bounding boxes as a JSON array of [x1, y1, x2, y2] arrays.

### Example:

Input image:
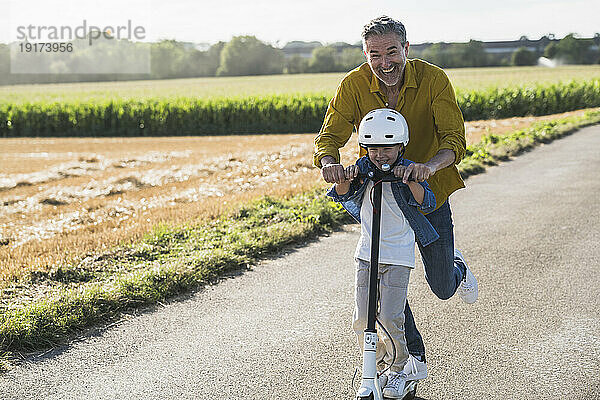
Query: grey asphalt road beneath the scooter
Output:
[[0, 126, 600, 400]]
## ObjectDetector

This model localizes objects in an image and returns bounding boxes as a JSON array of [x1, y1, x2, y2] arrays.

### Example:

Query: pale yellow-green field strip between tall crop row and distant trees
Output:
[[0, 65, 600, 104]]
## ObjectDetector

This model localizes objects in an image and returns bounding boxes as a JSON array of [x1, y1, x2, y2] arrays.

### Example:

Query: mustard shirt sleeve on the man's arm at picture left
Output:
[[313, 80, 357, 168]]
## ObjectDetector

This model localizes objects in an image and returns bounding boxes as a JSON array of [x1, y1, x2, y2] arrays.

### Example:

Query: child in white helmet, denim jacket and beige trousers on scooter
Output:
[[328, 108, 438, 398]]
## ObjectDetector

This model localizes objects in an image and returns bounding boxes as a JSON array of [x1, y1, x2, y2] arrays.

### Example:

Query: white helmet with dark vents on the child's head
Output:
[[358, 108, 408, 147]]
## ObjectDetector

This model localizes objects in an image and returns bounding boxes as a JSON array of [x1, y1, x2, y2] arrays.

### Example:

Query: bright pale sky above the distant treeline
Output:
[[0, 0, 600, 47]]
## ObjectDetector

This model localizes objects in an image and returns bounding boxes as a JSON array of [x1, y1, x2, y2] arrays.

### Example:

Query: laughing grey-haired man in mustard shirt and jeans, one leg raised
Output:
[[314, 16, 478, 380]]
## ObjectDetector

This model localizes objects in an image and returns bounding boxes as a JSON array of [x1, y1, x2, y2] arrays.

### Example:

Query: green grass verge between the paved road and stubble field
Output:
[[0, 111, 600, 370]]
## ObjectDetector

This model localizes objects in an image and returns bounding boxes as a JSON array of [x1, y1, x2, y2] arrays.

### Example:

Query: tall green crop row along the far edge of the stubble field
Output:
[[0, 79, 600, 137]]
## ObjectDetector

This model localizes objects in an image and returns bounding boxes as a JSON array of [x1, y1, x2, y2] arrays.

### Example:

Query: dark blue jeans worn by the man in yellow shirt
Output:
[[404, 201, 463, 356]]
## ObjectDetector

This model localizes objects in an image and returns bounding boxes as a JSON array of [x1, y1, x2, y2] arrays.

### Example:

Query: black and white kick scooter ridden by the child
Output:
[[356, 164, 417, 400]]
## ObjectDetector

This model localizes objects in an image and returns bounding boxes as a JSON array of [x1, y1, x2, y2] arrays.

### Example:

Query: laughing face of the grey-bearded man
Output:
[[364, 33, 408, 86]]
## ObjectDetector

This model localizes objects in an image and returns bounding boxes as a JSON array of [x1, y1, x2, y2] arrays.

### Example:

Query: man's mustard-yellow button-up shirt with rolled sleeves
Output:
[[314, 59, 466, 211]]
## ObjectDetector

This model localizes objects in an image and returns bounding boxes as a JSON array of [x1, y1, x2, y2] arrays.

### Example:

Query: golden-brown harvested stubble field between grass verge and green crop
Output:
[[0, 111, 583, 289]]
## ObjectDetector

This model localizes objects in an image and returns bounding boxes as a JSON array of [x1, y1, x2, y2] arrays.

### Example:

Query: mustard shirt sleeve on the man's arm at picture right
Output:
[[432, 71, 467, 164]]
